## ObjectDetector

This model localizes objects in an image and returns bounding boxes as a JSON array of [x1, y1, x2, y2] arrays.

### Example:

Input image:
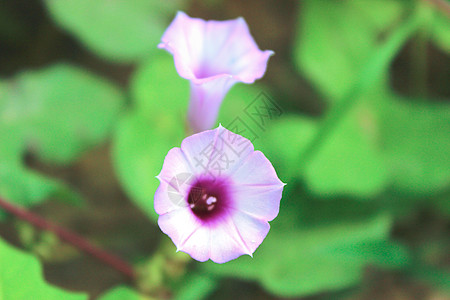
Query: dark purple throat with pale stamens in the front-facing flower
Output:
[[188, 179, 229, 221]]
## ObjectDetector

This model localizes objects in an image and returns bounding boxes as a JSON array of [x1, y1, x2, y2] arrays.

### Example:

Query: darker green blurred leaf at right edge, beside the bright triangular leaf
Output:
[[380, 97, 450, 195]]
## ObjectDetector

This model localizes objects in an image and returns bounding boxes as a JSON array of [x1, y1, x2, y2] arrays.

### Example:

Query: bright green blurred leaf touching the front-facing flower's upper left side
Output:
[[113, 112, 183, 220]]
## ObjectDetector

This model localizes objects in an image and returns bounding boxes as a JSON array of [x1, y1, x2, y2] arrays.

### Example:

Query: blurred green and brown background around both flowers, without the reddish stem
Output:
[[0, 0, 450, 300]]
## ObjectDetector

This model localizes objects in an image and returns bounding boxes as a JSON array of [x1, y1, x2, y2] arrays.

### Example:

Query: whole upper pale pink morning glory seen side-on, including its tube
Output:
[[158, 12, 273, 132]]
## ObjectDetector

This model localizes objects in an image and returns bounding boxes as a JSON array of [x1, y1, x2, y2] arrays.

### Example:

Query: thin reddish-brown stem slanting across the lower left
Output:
[[0, 198, 135, 280]]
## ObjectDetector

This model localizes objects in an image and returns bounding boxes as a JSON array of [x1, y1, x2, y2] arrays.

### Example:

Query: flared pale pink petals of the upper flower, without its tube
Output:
[[158, 12, 273, 84]]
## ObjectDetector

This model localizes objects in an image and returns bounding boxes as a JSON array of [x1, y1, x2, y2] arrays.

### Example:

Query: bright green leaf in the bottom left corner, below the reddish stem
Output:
[[0, 239, 88, 300]]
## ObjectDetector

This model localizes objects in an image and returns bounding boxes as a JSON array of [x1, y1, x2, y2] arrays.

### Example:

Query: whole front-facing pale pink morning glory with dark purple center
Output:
[[155, 125, 284, 263]]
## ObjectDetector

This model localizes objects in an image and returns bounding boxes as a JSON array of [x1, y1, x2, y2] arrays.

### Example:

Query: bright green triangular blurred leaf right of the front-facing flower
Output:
[[304, 105, 388, 199]]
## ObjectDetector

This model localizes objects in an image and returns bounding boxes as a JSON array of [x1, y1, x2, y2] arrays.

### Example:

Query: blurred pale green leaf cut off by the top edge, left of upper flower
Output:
[[45, 0, 186, 62]]
